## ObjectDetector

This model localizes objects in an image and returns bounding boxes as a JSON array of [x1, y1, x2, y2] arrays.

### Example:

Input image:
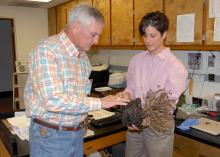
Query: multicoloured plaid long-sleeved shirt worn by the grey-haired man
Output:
[[24, 32, 101, 126]]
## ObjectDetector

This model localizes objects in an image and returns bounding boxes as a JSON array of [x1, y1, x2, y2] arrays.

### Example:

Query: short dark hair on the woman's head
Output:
[[139, 11, 169, 36]]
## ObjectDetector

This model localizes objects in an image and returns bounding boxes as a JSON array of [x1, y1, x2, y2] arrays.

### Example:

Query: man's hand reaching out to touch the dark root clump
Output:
[[101, 95, 130, 108]]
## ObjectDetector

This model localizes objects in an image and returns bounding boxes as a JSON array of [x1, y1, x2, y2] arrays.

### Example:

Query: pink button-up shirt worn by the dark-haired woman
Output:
[[127, 48, 188, 111]]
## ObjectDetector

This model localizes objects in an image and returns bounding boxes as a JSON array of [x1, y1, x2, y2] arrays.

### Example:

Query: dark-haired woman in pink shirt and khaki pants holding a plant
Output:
[[118, 11, 188, 157]]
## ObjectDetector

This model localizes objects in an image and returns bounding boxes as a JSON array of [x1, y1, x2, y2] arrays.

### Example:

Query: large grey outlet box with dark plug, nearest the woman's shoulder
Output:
[[188, 53, 202, 70]]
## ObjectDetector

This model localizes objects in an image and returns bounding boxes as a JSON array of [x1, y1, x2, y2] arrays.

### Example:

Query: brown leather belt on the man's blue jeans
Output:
[[33, 118, 83, 131]]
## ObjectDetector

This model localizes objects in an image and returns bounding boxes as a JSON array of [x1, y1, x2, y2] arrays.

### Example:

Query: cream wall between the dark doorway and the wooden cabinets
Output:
[[0, 6, 48, 60]]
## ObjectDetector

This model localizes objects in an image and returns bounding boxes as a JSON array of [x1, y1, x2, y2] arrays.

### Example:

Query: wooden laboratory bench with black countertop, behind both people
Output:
[[0, 89, 220, 157]]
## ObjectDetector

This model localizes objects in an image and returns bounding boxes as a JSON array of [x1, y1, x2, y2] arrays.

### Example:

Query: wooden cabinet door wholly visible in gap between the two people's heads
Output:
[[111, 0, 133, 46]]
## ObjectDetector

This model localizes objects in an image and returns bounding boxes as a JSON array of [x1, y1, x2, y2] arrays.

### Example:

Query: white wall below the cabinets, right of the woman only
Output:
[[174, 51, 220, 98]]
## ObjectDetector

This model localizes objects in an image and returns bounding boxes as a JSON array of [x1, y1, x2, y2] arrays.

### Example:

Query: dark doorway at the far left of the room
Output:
[[0, 18, 15, 97]]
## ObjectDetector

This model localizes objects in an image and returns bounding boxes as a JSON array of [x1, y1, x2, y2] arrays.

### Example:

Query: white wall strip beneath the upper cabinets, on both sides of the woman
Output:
[[89, 49, 220, 98]]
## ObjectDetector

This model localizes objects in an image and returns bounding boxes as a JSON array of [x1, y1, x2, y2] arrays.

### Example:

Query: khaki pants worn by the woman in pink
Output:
[[125, 125, 174, 157]]
